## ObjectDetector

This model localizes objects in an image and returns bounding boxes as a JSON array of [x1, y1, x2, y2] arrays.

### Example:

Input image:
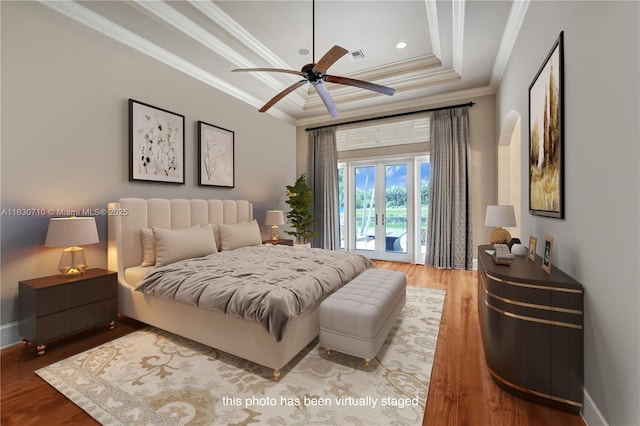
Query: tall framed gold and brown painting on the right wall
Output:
[[529, 32, 564, 219]]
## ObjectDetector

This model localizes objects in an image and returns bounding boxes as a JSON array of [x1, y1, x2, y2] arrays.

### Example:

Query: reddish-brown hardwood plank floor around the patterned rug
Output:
[[0, 261, 585, 426]]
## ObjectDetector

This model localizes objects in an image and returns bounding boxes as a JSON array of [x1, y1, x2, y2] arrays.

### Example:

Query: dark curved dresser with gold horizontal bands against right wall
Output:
[[478, 245, 584, 413]]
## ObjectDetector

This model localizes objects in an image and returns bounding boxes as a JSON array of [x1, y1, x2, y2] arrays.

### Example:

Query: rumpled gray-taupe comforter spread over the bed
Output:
[[136, 245, 374, 341]]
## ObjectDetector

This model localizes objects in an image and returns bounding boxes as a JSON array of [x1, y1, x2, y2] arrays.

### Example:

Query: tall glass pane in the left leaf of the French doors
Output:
[[354, 166, 376, 250]]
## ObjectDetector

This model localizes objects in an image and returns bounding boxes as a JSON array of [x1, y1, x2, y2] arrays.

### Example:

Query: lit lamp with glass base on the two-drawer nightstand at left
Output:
[[44, 216, 100, 276]]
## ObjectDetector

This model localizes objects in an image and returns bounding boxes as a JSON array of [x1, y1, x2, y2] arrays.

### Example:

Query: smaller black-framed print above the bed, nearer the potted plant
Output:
[[198, 121, 235, 188]]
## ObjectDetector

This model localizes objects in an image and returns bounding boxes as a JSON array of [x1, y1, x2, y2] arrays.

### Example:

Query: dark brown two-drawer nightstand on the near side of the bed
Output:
[[19, 268, 118, 355]]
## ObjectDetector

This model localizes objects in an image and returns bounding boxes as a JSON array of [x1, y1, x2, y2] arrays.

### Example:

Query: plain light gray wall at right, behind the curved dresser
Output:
[[497, 1, 640, 426]]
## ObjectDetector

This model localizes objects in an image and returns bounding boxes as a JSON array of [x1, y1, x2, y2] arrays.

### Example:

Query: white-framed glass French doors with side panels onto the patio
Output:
[[338, 155, 429, 263]]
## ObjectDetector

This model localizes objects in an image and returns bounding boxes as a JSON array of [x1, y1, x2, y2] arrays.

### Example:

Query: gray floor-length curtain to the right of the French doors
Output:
[[425, 107, 473, 269]]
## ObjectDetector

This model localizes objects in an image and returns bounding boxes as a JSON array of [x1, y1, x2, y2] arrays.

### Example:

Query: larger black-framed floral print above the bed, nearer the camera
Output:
[[129, 99, 184, 184]]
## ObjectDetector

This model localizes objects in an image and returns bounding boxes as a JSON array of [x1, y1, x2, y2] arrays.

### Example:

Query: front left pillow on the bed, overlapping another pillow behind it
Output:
[[153, 225, 218, 266]]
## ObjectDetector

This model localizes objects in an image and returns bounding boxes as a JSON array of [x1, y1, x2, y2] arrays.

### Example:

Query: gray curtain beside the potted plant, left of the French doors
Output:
[[307, 127, 338, 250]]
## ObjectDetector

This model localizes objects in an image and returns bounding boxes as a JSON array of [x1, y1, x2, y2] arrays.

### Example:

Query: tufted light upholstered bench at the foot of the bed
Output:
[[319, 269, 407, 366]]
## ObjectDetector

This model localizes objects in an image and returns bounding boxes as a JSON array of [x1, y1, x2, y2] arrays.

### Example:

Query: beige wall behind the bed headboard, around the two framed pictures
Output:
[[1, 2, 296, 332]]
